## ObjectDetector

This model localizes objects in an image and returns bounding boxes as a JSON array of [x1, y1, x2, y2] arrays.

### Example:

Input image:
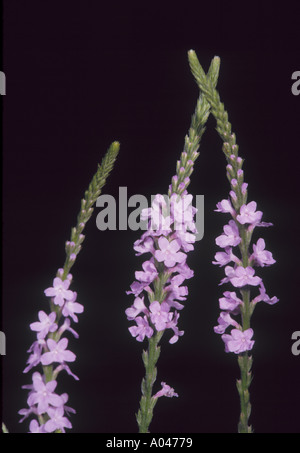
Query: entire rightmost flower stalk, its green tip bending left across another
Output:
[[189, 50, 278, 433]]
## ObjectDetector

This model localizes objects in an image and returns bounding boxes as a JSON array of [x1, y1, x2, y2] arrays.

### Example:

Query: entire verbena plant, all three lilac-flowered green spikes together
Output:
[[2, 50, 278, 433]]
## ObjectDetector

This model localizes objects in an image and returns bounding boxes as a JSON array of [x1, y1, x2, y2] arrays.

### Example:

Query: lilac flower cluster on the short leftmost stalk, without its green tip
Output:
[[19, 269, 83, 433]]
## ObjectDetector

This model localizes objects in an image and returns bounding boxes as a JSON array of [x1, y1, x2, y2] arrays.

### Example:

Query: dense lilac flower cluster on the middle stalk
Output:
[[125, 186, 197, 343]]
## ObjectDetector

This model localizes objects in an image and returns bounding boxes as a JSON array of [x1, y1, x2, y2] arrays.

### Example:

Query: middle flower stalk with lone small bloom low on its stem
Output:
[[126, 59, 219, 433]]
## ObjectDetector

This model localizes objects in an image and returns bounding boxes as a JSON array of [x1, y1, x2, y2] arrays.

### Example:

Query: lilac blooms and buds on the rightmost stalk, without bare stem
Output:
[[213, 155, 278, 354]]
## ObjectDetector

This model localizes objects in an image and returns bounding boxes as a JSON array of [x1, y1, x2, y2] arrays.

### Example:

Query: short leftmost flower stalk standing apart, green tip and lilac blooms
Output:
[[19, 142, 120, 433]]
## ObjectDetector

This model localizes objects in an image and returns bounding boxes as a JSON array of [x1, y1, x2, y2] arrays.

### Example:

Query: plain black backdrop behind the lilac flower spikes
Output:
[[1, 0, 300, 433]]
